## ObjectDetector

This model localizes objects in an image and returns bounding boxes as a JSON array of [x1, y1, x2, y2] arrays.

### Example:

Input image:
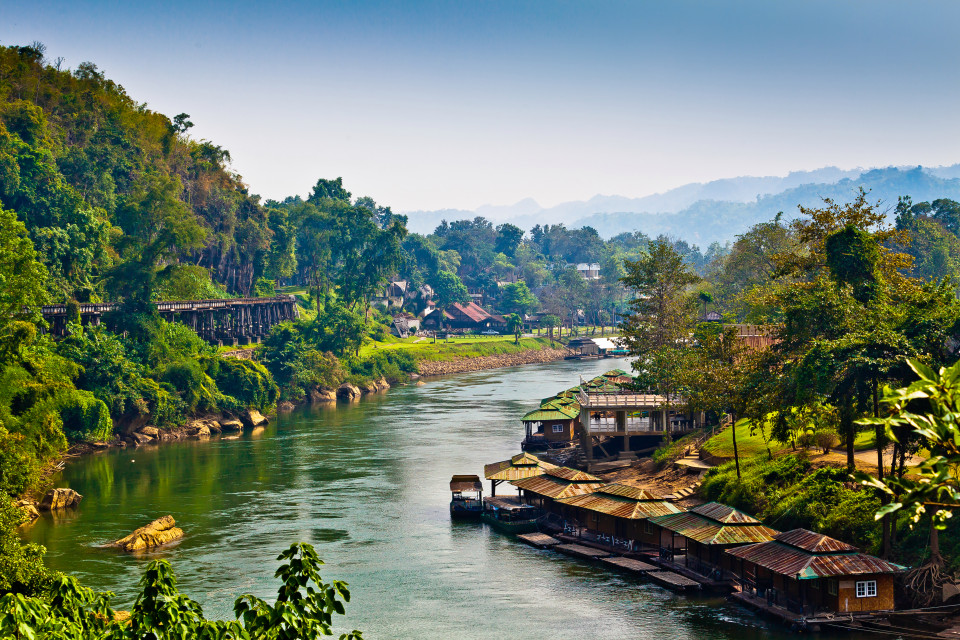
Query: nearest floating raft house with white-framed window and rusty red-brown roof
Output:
[[725, 529, 904, 615]]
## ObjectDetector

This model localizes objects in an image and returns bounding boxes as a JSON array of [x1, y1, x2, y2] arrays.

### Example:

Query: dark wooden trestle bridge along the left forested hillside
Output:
[[43, 295, 299, 345]]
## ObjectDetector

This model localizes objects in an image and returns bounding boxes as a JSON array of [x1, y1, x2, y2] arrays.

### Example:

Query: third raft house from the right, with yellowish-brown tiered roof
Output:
[[556, 483, 682, 551]]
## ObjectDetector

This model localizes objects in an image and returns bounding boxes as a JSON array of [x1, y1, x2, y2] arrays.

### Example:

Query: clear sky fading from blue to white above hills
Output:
[[0, 0, 960, 211]]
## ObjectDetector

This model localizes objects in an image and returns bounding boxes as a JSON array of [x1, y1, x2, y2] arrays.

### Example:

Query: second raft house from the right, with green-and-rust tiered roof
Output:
[[647, 502, 779, 579]]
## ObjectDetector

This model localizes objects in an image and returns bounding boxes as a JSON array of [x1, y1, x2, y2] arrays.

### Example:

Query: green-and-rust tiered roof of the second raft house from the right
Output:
[[650, 502, 779, 545]]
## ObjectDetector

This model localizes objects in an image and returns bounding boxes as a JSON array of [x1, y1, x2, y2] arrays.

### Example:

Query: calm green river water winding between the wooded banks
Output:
[[26, 360, 860, 640]]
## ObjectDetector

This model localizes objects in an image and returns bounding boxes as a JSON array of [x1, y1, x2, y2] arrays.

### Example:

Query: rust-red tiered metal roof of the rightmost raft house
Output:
[[726, 529, 905, 580]]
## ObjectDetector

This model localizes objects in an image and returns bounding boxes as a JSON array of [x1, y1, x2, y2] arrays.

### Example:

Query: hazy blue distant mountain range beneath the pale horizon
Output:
[[405, 164, 960, 249]]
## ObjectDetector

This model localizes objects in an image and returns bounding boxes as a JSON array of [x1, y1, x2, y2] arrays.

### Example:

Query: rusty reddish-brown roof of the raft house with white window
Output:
[[726, 529, 906, 580]]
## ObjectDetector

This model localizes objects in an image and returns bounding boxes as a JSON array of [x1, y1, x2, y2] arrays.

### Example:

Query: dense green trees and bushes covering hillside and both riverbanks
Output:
[[0, 43, 960, 637]]
